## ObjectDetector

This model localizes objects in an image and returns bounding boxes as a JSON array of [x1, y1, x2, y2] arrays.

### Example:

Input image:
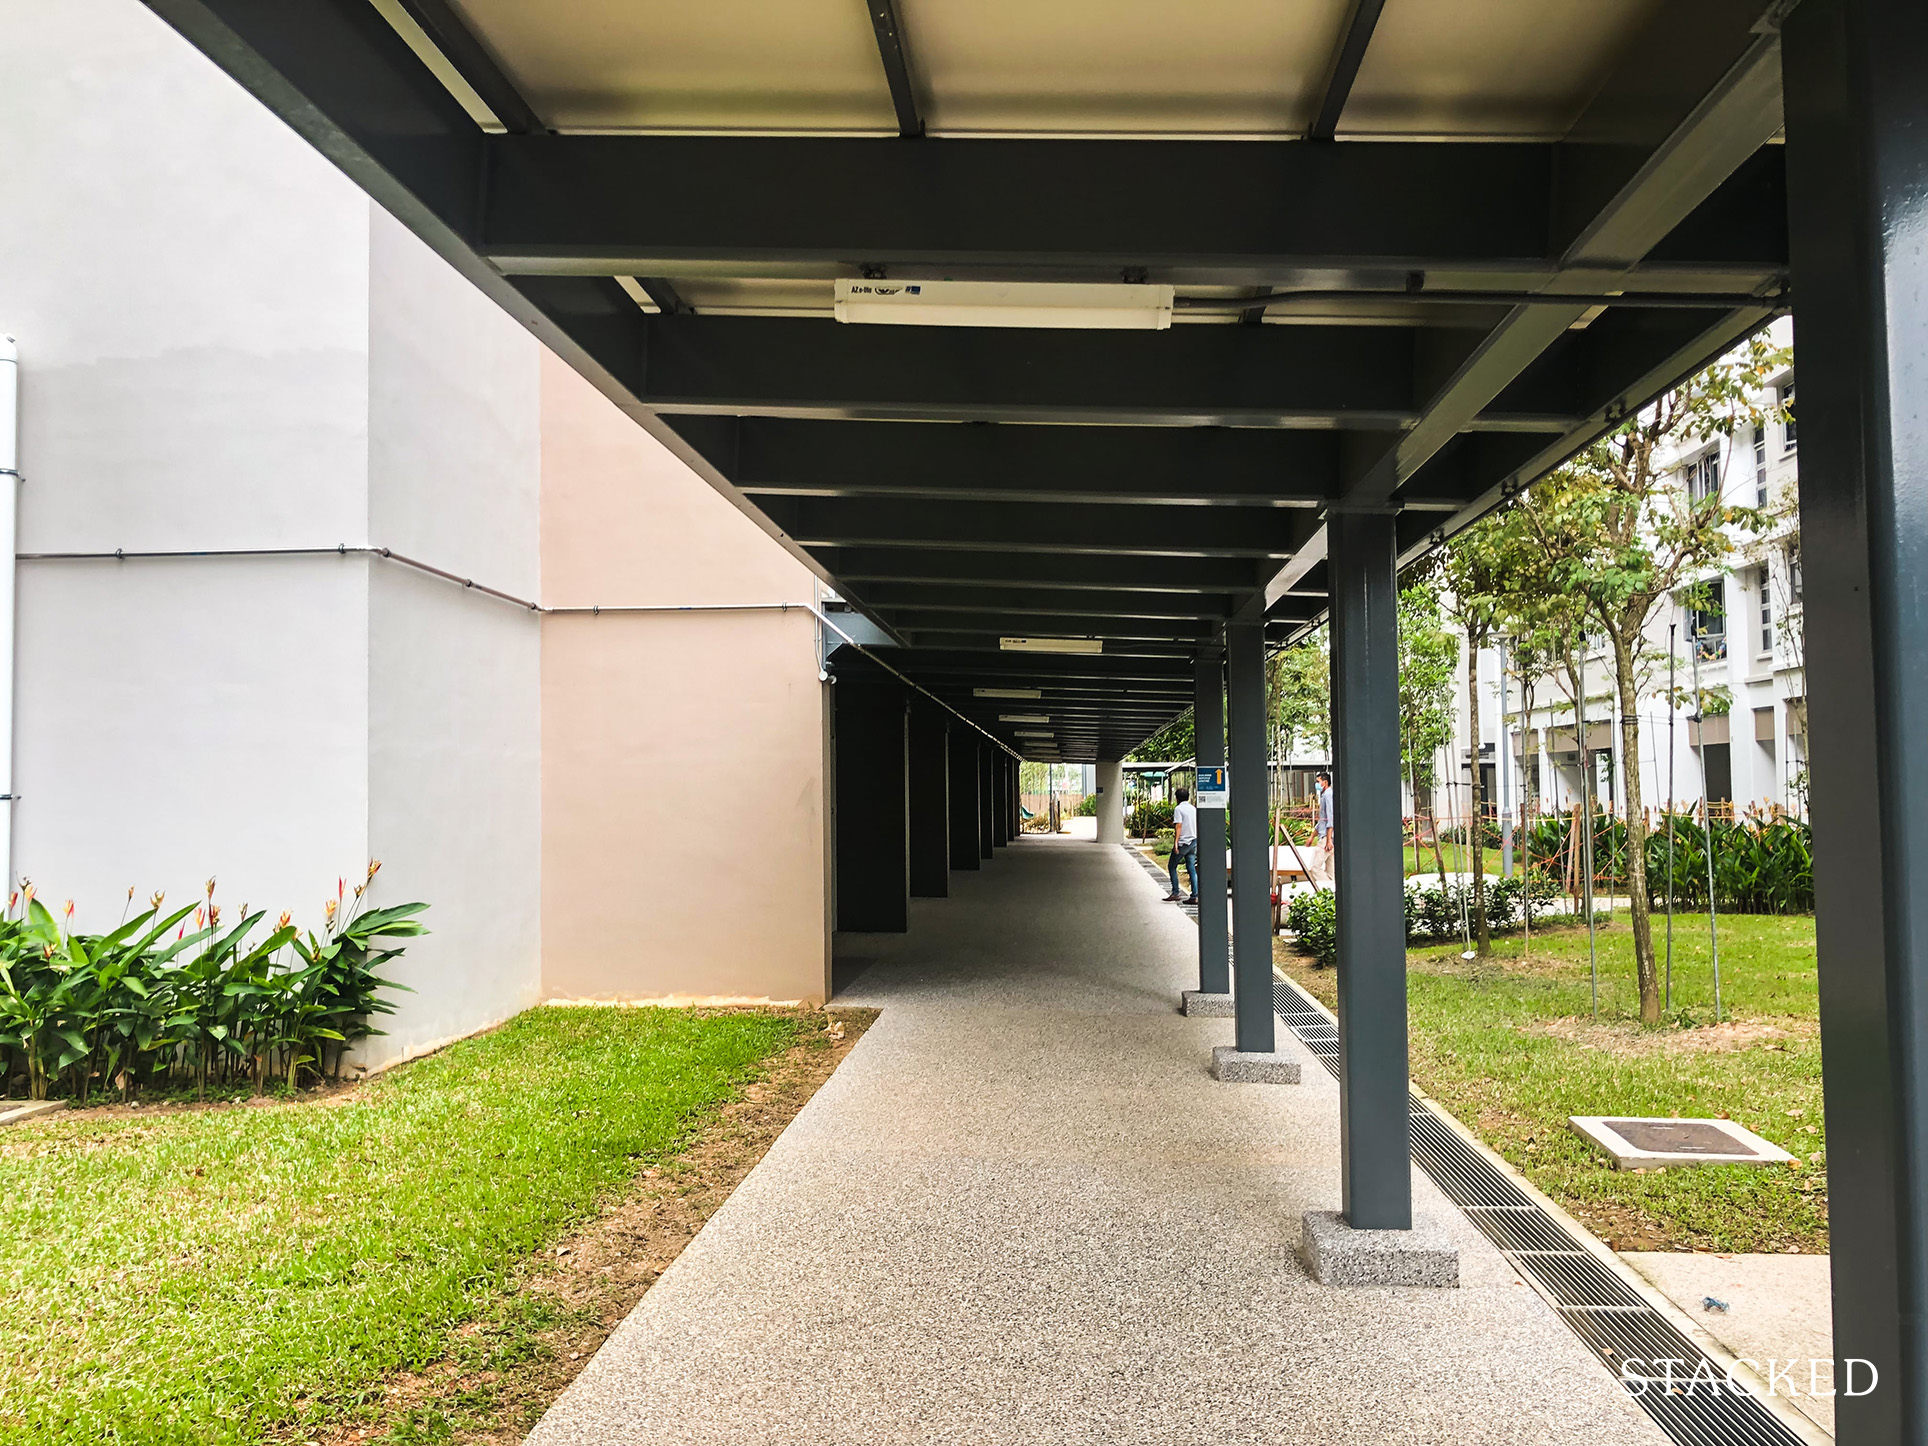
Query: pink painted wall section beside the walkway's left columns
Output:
[[542, 353, 829, 1001]]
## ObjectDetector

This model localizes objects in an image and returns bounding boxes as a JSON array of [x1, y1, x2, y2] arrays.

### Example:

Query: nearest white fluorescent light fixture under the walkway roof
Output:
[[837, 280, 1172, 332]]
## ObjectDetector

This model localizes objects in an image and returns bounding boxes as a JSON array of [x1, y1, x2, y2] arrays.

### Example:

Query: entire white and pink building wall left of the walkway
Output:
[[0, 0, 831, 1064]]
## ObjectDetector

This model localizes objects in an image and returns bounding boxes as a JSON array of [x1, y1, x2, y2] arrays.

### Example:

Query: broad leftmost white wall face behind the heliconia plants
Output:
[[0, 0, 368, 927]]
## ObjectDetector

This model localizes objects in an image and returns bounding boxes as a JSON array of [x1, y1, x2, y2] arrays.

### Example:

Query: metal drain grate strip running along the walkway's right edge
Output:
[[1272, 977, 1801, 1446]]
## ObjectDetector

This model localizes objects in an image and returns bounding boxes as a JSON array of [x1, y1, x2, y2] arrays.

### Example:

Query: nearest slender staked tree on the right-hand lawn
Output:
[[1517, 337, 1789, 1024]]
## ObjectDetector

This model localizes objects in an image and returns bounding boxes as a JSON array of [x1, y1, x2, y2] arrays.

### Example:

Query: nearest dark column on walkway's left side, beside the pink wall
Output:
[[837, 677, 910, 933]]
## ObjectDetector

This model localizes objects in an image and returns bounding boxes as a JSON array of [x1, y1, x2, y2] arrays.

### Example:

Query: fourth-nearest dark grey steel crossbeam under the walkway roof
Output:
[[762, 497, 1315, 557]]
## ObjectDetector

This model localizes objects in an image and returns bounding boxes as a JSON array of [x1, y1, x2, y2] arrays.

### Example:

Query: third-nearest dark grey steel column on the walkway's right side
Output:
[[1224, 623, 1272, 1055]]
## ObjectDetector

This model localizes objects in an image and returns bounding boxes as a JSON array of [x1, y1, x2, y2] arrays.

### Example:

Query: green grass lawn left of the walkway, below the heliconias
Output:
[[0, 1008, 800, 1446]]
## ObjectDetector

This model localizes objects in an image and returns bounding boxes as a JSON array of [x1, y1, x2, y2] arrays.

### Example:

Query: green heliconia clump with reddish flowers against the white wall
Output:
[[0, 860, 428, 1103]]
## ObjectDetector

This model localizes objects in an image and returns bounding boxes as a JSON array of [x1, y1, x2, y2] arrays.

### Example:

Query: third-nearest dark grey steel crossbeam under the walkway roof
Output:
[[671, 416, 1342, 505]]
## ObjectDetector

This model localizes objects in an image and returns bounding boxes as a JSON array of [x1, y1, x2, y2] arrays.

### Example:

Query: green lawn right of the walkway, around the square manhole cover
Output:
[[1290, 910, 1828, 1251]]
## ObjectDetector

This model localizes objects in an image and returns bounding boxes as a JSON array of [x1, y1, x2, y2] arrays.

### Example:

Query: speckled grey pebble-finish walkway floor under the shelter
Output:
[[530, 839, 1664, 1446]]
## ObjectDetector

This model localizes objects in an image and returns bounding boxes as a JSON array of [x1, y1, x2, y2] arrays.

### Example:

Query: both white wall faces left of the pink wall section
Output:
[[0, 0, 540, 1062]]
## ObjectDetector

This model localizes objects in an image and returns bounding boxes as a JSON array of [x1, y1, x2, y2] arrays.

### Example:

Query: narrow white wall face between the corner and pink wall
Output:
[[364, 208, 542, 1057]]
